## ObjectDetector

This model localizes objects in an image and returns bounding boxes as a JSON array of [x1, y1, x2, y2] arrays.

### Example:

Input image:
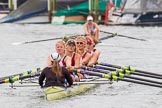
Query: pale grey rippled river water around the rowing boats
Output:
[[0, 24, 162, 108]]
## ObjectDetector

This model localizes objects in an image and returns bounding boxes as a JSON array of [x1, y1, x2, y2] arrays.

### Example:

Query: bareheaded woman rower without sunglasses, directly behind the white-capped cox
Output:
[[47, 40, 71, 67]]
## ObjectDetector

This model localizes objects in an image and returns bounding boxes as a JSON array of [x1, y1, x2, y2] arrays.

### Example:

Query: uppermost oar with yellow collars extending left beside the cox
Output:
[[0, 68, 41, 84]]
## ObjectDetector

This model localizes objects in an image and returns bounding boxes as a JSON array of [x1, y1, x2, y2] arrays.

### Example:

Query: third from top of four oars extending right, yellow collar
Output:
[[82, 66, 162, 84]]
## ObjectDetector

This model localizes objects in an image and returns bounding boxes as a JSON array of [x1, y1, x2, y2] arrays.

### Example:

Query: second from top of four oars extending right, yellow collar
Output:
[[89, 65, 162, 79]]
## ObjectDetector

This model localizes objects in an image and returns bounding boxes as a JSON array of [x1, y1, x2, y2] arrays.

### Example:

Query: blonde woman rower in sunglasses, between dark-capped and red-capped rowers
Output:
[[76, 36, 91, 65]]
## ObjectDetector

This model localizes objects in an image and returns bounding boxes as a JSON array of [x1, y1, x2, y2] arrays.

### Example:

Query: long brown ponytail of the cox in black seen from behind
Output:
[[51, 59, 62, 78]]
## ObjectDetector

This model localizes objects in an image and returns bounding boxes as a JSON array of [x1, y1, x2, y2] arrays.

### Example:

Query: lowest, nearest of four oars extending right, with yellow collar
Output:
[[75, 69, 162, 88]]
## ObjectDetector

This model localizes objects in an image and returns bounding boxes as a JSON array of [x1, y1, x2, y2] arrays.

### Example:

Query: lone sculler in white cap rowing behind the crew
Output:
[[84, 15, 100, 43]]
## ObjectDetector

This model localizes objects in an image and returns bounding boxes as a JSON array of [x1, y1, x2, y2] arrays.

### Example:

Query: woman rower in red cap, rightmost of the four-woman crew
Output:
[[86, 36, 100, 65]]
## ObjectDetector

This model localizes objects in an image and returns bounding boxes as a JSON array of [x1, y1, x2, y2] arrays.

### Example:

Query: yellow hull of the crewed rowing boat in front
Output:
[[43, 79, 110, 101]]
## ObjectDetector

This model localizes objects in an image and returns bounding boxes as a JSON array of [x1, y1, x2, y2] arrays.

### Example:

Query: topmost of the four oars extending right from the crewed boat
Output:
[[97, 62, 162, 77]]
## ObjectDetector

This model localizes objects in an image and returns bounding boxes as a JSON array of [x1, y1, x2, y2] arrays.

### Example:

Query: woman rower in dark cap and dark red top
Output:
[[65, 39, 80, 81]]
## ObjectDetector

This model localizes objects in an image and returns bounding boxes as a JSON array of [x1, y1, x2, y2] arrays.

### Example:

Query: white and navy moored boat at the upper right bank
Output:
[[108, 0, 162, 25]]
